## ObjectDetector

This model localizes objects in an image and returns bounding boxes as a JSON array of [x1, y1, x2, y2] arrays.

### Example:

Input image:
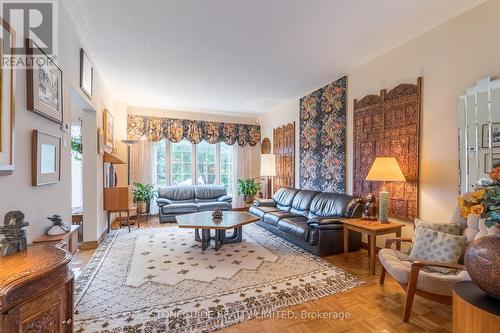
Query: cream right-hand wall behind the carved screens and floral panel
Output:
[[260, 0, 500, 230]]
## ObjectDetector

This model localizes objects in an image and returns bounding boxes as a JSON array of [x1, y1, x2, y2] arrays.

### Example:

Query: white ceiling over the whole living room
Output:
[[65, 0, 483, 115]]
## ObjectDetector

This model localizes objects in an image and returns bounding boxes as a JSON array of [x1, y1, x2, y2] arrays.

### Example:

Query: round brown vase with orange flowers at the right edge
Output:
[[458, 167, 500, 299]]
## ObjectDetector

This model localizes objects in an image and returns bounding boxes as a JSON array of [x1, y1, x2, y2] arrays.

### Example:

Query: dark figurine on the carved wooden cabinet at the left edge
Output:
[[0, 210, 29, 256]]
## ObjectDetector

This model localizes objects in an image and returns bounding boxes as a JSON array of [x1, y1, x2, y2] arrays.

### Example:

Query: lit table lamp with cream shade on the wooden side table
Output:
[[365, 157, 406, 223]]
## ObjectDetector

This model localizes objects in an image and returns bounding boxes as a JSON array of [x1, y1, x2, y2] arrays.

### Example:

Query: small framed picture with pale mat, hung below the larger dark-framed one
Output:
[[31, 130, 61, 186]]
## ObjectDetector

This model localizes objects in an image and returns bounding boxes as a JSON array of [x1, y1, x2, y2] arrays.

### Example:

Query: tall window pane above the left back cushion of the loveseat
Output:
[[170, 139, 193, 185]]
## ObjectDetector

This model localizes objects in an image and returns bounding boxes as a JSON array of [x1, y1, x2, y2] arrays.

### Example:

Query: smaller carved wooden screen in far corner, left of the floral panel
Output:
[[273, 122, 295, 193]]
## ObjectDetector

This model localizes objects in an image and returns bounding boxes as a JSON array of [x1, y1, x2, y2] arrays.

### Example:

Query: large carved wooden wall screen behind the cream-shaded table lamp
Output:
[[353, 78, 422, 220]]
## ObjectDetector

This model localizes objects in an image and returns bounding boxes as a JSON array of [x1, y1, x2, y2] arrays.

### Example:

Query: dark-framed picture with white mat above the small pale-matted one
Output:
[[26, 39, 63, 124]]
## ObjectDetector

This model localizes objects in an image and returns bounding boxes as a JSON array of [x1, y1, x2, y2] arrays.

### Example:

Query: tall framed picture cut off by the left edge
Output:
[[0, 17, 16, 171]]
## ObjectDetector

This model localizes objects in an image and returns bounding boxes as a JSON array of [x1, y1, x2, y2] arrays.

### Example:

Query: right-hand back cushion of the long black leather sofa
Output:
[[308, 192, 362, 218]]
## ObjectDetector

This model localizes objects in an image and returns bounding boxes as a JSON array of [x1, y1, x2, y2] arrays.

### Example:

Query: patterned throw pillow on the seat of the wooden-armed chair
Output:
[[408, 226, 467, 274]]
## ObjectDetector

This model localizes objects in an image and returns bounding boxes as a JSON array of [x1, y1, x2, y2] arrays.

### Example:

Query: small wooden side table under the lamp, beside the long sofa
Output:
[[340, 219, 405, 275]]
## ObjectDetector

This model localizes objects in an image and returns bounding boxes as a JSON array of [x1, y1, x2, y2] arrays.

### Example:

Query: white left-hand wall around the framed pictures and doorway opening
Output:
[[0, 2, 122, 242]]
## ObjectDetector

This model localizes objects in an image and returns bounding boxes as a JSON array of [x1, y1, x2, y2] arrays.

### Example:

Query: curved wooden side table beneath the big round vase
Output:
[[453, 281, 500, 333]]
